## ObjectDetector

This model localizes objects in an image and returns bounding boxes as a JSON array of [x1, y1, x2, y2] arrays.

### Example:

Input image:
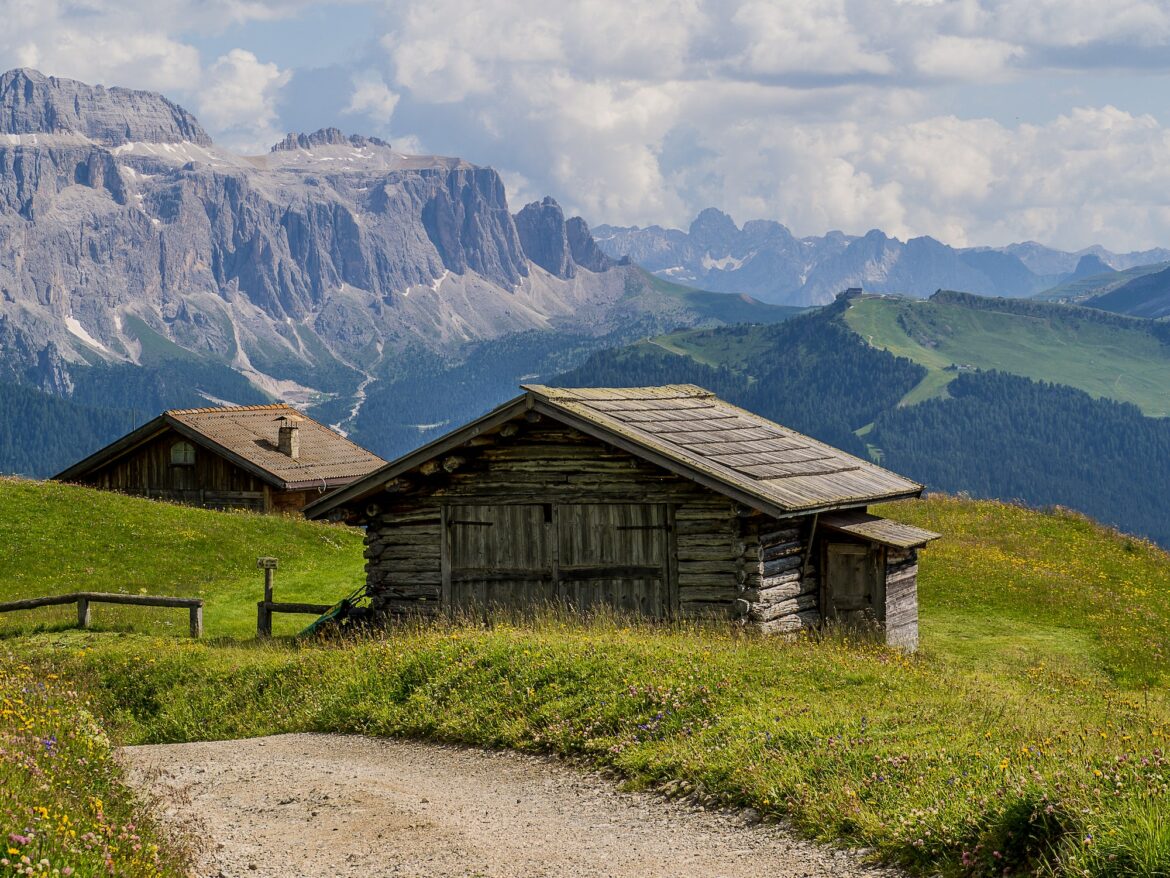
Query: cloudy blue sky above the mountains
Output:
[[0, 0, 1170, 249]]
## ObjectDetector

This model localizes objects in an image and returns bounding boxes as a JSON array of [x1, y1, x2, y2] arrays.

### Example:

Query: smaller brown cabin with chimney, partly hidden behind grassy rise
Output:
[[53, 405, 386, 513]]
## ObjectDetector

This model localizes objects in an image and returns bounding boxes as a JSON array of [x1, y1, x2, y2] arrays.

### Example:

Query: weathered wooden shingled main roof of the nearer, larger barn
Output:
[[305, 384, 922, 517]]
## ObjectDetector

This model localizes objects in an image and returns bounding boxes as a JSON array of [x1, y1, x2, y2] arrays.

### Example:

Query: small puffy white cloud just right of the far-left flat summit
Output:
[[199, 49, 291, 151]]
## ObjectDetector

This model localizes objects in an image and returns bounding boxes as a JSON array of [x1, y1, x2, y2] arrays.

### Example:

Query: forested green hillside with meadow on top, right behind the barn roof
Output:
[[550, 304, 1170, 546]]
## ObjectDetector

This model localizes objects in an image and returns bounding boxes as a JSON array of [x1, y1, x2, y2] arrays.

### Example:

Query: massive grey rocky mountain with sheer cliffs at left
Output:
[[0, 70, 775, 447]]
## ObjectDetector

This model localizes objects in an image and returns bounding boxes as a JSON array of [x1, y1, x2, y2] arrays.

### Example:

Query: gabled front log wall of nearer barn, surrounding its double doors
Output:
[[355, 419, 759, 618]]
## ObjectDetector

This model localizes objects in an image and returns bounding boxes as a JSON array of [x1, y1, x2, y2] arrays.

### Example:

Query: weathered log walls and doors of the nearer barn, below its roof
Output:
[[347, 402, 917, 650]]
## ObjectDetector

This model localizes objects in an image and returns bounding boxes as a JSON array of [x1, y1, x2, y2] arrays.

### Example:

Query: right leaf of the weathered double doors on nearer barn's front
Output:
[[557, 503, 670, 618]]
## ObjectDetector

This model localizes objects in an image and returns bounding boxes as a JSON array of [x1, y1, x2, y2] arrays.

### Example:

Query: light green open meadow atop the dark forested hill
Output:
[[845, 296, 1170, 418]]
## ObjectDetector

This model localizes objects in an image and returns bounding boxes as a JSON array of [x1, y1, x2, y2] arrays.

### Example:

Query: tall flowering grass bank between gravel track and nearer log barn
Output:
[[39, 617, 1170, 876]]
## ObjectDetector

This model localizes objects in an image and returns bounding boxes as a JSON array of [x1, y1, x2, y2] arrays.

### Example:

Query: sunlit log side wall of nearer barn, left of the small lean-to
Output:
[[739, 516, 821, 635]]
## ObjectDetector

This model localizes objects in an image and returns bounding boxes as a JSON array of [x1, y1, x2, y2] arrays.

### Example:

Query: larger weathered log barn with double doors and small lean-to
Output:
[[305, 385, 937, 650]]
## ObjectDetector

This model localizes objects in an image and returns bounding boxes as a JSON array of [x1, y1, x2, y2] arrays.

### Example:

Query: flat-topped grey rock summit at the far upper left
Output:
[[0, 68, 212, 146]]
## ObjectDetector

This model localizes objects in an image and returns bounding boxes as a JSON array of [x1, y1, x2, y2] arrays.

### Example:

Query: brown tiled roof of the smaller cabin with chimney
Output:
[[54, 405, 386, 491]]
